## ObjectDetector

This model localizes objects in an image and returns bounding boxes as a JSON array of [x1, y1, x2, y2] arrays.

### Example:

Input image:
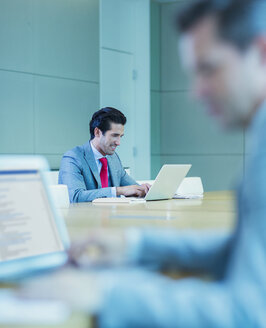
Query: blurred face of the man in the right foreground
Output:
[[180, 17, 263, 127]]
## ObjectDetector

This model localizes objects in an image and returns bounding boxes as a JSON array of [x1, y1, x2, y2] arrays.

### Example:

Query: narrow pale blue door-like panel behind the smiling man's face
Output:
[[100, 0, 150, 180]]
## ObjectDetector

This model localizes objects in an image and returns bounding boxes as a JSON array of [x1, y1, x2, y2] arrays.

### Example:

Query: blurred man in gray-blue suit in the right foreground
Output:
[[69, 0, 266, 328]]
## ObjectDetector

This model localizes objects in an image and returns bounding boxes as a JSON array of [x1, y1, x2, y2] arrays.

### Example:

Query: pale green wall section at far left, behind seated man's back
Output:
[[0, 0, 99, 168]]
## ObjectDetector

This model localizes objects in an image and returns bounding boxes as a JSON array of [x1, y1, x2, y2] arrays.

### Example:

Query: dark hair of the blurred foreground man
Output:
[[176, 0, 266, 50]]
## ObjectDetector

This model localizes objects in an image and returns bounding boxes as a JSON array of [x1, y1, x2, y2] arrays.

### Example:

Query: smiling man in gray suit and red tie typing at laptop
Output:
[[58, 107, 149, 203]]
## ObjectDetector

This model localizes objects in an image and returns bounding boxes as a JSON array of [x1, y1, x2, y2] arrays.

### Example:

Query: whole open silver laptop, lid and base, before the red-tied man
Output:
[[93, 164, 191, 204]]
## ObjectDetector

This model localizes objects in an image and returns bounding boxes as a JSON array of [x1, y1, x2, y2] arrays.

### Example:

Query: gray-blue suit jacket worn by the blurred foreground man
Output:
[[99, 103, 266, 328]]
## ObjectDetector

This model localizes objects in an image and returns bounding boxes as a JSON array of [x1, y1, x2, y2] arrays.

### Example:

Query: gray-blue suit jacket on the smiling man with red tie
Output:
[[58, 141, 137, 203]]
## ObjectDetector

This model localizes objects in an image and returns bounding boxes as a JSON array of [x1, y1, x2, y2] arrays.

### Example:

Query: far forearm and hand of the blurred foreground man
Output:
[[70, 229, 233, 278]]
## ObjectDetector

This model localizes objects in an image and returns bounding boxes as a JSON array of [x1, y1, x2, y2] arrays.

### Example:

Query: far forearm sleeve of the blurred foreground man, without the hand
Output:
[[131, 230, 233, 276]]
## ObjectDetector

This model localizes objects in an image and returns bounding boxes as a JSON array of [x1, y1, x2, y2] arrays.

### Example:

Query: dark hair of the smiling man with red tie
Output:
[[90, 107, 127, 139]]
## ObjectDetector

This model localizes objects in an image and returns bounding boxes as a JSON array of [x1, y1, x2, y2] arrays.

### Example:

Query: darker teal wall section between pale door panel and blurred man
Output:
[[152, 1, 245, 190]]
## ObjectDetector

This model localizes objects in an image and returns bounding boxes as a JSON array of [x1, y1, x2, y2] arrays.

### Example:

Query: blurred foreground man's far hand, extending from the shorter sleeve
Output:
[[68, 229, 127, 267]]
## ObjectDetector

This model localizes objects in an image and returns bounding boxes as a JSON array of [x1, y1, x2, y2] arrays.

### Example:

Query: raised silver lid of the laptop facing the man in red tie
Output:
[[144, 164, 191, 200]]
